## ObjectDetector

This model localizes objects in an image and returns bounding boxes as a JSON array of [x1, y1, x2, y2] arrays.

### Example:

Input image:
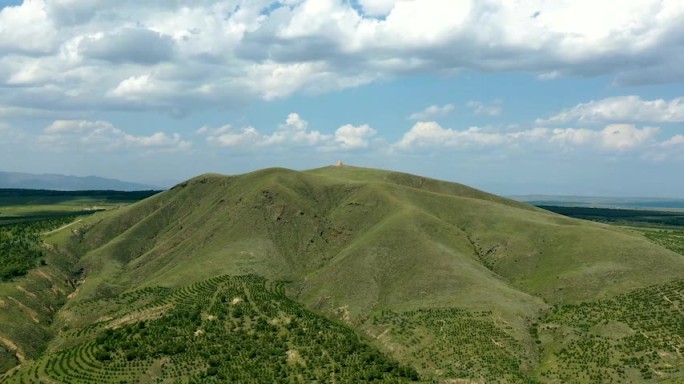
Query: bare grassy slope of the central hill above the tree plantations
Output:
[[5, 167, 684, 378]]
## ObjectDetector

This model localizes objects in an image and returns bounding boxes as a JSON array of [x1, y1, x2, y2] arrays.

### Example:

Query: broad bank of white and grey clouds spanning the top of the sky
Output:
[[0, 0, 684, 114]]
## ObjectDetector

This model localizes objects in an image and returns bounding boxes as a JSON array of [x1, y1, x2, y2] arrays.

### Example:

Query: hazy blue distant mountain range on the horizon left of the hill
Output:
[[0, 172, 164, 191]]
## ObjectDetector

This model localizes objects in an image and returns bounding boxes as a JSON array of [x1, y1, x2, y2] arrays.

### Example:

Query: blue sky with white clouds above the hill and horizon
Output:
[[0, 0, 684, 198]]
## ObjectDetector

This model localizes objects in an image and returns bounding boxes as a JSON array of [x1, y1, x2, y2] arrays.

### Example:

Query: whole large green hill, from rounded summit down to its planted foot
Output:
[[0, 167, 684, 382]]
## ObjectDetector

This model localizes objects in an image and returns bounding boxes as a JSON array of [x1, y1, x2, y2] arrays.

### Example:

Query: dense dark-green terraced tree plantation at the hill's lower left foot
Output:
[[8, 276, 419, 383]]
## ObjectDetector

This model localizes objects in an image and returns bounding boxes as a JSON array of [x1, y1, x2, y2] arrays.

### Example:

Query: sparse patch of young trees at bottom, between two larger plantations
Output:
[[372, 308, 536, 384]]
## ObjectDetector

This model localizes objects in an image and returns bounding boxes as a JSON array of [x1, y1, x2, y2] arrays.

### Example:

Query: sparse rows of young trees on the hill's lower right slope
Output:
[[536, 280, 684, 383]]
